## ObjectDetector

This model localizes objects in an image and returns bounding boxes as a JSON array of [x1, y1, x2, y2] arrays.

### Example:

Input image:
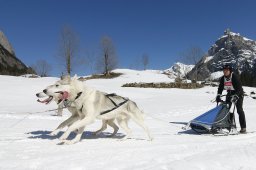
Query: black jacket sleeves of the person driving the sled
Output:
[[218, 73, 244, 96]]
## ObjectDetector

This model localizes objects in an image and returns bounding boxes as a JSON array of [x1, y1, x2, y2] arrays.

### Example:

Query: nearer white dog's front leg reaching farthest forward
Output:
[[60, 116, 94, 140]]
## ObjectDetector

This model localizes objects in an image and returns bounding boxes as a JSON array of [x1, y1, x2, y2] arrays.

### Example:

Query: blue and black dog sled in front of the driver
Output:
[[183, 96, 238, 135]]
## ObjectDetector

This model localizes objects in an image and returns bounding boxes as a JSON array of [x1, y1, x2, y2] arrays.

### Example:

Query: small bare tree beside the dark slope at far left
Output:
[[31, 60, 52, 77]]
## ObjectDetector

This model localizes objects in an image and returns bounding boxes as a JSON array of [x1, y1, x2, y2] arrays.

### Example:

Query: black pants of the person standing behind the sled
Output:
[[226, 96, 246, 128]]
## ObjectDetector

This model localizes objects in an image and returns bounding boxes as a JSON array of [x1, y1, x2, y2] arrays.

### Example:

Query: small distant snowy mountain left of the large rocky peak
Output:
[[163, 62, 194, 78]]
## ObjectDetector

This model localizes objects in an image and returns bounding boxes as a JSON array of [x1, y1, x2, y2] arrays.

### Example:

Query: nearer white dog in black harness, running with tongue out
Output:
[[44, 77, 152, 144]]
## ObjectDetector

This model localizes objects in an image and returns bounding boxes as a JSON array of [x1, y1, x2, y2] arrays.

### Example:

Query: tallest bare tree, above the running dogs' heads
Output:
[[59, 26, 79, 75]]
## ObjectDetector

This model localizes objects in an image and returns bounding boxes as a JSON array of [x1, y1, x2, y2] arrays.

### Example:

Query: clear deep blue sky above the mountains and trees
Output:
[[0, 0, 256, 76]]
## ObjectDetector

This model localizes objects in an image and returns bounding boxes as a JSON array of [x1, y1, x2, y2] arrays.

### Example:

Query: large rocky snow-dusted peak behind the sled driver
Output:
[[188, 29, 256, 80]]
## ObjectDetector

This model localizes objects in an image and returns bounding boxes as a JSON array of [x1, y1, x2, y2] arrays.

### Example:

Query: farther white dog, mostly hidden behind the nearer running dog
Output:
[[36, 77, 119, 137]]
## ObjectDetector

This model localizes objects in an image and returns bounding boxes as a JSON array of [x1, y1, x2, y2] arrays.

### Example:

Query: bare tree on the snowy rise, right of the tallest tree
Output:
[[97, 36, 118, 75]]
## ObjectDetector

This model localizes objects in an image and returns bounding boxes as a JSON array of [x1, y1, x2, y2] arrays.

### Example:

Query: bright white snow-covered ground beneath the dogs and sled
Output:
[[0, 70, 256, 170]]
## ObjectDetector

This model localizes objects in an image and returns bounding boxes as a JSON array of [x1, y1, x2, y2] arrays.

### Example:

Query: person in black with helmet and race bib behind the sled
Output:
[[216, 64, 246, 133]]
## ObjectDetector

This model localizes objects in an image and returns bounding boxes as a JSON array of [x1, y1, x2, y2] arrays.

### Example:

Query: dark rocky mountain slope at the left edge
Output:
[[0, 31, 34, 76]]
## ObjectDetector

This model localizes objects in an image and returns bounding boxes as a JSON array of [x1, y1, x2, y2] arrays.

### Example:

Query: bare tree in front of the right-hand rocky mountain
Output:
[[181, 46, 205, 81]]
